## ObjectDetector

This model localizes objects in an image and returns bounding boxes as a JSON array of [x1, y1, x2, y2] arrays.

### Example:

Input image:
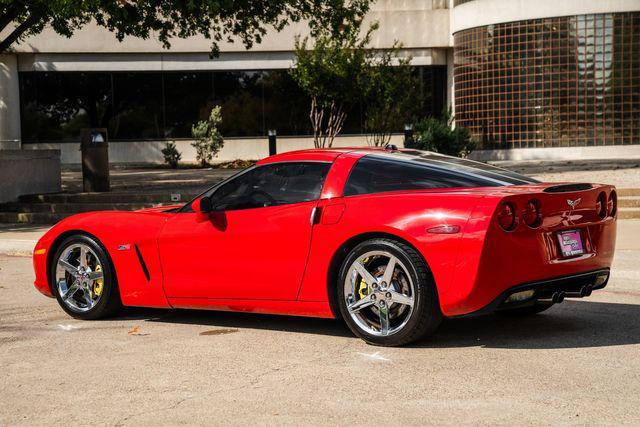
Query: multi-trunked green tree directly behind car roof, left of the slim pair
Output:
[[289, 21, 378, 147]]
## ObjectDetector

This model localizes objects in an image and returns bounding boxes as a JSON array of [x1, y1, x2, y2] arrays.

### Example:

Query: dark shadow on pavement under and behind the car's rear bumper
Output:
[[424, 300, 640, 349]]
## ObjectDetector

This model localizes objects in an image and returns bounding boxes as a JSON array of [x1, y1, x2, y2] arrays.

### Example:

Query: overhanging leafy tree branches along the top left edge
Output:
[[0, 0, 371, 55]]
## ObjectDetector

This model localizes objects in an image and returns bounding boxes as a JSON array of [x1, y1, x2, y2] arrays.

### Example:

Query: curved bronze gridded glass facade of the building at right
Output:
[[454, 12, 640, 149]]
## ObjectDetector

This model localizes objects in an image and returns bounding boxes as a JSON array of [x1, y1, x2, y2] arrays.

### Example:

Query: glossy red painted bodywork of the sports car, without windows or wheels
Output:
[[33, 148, 616, 317]]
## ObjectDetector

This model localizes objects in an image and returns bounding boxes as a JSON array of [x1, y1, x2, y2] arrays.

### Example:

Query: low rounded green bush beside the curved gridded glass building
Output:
[[407, 110, 476, 157]]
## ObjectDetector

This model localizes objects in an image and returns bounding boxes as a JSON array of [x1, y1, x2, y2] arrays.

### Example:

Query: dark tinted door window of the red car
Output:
[[211, 162, 331, 210]]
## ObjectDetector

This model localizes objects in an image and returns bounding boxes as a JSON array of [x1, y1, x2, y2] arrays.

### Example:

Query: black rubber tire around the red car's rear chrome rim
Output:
[[337, 238, 442, 347]]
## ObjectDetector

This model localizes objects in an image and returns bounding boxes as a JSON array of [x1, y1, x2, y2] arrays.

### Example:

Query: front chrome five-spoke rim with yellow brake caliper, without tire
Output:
[[55, 243, 104, 313]]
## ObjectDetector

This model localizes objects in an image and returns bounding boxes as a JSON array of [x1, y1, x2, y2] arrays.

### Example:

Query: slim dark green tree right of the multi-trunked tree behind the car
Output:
[[361, 43, 422, 146]]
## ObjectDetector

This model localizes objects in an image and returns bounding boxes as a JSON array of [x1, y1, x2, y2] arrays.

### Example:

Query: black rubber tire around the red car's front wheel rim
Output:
[[49, 234, 122, 320]]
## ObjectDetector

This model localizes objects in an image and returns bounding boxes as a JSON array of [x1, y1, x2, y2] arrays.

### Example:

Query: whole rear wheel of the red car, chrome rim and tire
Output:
[[338, 239, 442, 346]]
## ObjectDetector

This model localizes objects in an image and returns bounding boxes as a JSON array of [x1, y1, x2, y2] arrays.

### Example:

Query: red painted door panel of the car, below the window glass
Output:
[[158, 202, 317, 300]]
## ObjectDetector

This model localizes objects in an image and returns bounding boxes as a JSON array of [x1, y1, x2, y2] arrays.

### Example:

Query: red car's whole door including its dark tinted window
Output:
[[158, 162, 330, 300]]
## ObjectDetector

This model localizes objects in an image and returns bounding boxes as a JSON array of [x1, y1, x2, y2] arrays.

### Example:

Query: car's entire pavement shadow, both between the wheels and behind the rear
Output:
[[114, 301, 640, 349]]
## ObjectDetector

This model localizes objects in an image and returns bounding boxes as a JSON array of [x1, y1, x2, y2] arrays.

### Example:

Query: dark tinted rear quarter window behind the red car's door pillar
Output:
[[344, 155, 495, 196]]
